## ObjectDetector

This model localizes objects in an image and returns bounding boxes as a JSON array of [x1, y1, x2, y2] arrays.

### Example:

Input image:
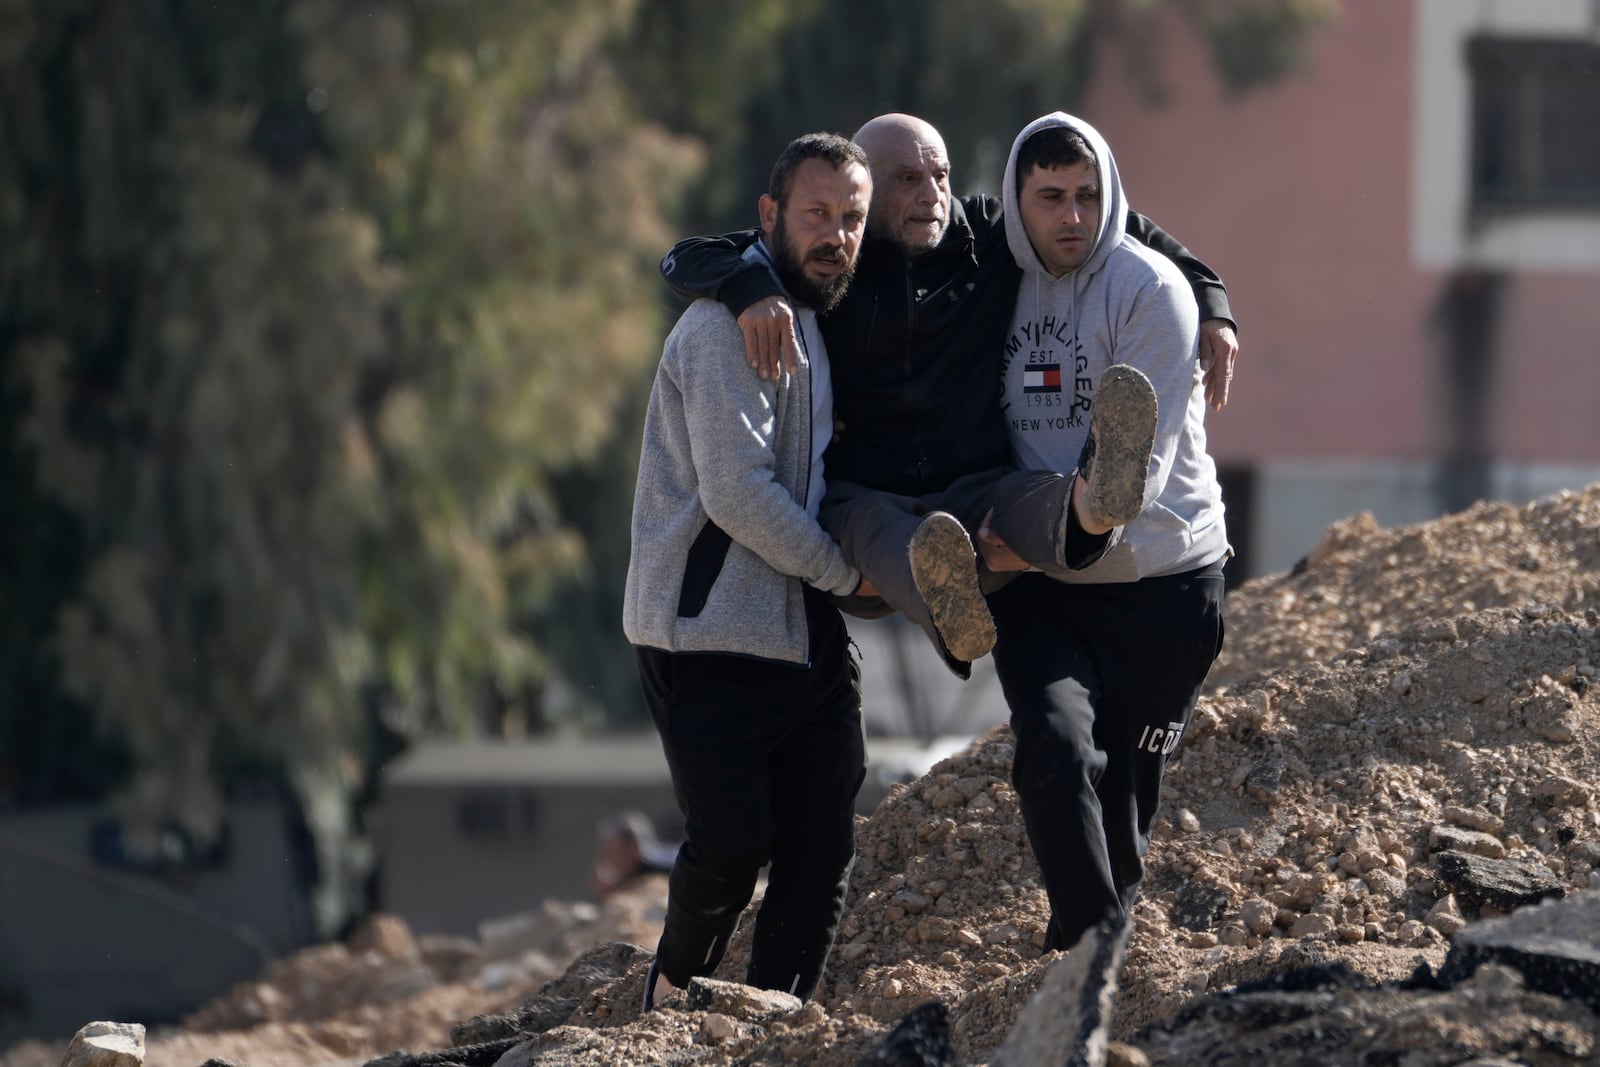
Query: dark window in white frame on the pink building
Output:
[[1467, 37, 1600, 214]]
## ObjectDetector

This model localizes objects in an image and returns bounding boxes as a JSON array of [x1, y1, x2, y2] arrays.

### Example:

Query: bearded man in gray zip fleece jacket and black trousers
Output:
[[622, 134, 872, 1009]]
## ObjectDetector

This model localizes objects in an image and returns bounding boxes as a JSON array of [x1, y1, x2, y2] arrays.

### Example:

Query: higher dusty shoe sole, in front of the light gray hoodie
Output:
[[1078, 363, 1160, 526]]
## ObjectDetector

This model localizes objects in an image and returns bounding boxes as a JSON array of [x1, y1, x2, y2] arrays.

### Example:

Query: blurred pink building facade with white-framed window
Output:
[[1083, 0, 1600, 576]]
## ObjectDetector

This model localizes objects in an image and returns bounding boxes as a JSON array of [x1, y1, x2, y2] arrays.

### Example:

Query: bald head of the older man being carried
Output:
[[854, 114, 952, 256]]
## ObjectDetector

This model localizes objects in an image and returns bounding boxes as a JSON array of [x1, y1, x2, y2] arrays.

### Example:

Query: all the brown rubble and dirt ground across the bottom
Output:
[[9, 486, 1600, 1067]]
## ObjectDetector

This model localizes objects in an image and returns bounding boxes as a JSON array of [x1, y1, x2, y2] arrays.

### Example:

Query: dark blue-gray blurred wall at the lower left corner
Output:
[[0, 801, 310, 1048]]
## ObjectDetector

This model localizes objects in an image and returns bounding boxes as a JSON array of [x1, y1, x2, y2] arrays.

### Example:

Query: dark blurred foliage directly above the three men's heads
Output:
[[694, 0, 1336, 229]]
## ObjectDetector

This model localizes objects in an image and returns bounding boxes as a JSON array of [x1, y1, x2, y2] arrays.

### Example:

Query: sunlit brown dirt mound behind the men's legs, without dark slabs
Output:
[[366, 605, 1600, 1067]]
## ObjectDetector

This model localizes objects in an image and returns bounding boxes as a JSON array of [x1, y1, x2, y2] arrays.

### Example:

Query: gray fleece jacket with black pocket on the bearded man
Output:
[[622, 243, 859, 664]]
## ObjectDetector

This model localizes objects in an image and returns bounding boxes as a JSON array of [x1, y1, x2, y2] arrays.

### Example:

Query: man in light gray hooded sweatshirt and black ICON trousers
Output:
[[979, 112, 1229, 949]]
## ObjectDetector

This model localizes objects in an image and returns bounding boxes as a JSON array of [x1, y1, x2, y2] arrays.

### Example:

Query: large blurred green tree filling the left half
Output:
[[0, 0, 796, 931]]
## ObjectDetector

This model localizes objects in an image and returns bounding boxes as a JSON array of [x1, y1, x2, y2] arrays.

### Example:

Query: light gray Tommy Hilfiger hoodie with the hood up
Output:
[[1000, 112, 1227, 582]]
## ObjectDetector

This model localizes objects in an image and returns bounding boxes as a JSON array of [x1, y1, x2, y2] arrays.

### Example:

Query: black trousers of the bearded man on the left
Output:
[[635, 587, 866, 998]]
